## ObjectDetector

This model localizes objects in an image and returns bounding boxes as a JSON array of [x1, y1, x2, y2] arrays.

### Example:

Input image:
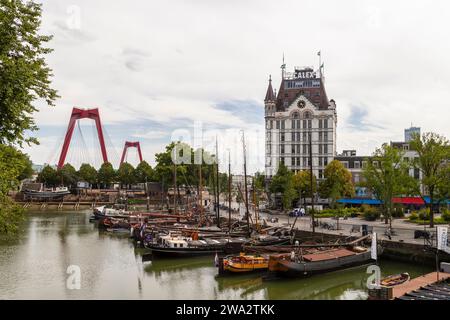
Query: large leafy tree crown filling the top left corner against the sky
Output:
[[0, 0, 58, 146]]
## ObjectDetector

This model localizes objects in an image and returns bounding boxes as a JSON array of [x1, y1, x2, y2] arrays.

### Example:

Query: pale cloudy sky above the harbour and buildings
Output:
[[22, 0, 450, 173]]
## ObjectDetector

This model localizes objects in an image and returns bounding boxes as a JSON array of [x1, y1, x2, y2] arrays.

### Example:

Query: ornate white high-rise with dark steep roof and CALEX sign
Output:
[[264, 67, 337, 179]]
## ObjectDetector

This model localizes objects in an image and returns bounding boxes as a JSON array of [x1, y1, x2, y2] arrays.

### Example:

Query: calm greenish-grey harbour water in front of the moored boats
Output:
[[0, 211, 430, 299]]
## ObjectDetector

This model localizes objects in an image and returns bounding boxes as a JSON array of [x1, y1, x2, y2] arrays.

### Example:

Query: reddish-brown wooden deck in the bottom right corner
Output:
[[392, 272, 450, 300]]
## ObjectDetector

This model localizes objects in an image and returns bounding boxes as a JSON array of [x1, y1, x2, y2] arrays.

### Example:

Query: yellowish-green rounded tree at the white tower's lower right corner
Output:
[[319, 160, 355, 207]]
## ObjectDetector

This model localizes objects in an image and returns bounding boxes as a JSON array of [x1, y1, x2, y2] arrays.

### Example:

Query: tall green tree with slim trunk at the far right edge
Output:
[[410, 132, 450, 227]]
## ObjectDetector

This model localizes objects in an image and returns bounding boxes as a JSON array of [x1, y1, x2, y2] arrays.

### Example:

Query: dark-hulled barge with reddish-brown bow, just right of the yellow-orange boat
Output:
[[269, 251, 372, 277]]
